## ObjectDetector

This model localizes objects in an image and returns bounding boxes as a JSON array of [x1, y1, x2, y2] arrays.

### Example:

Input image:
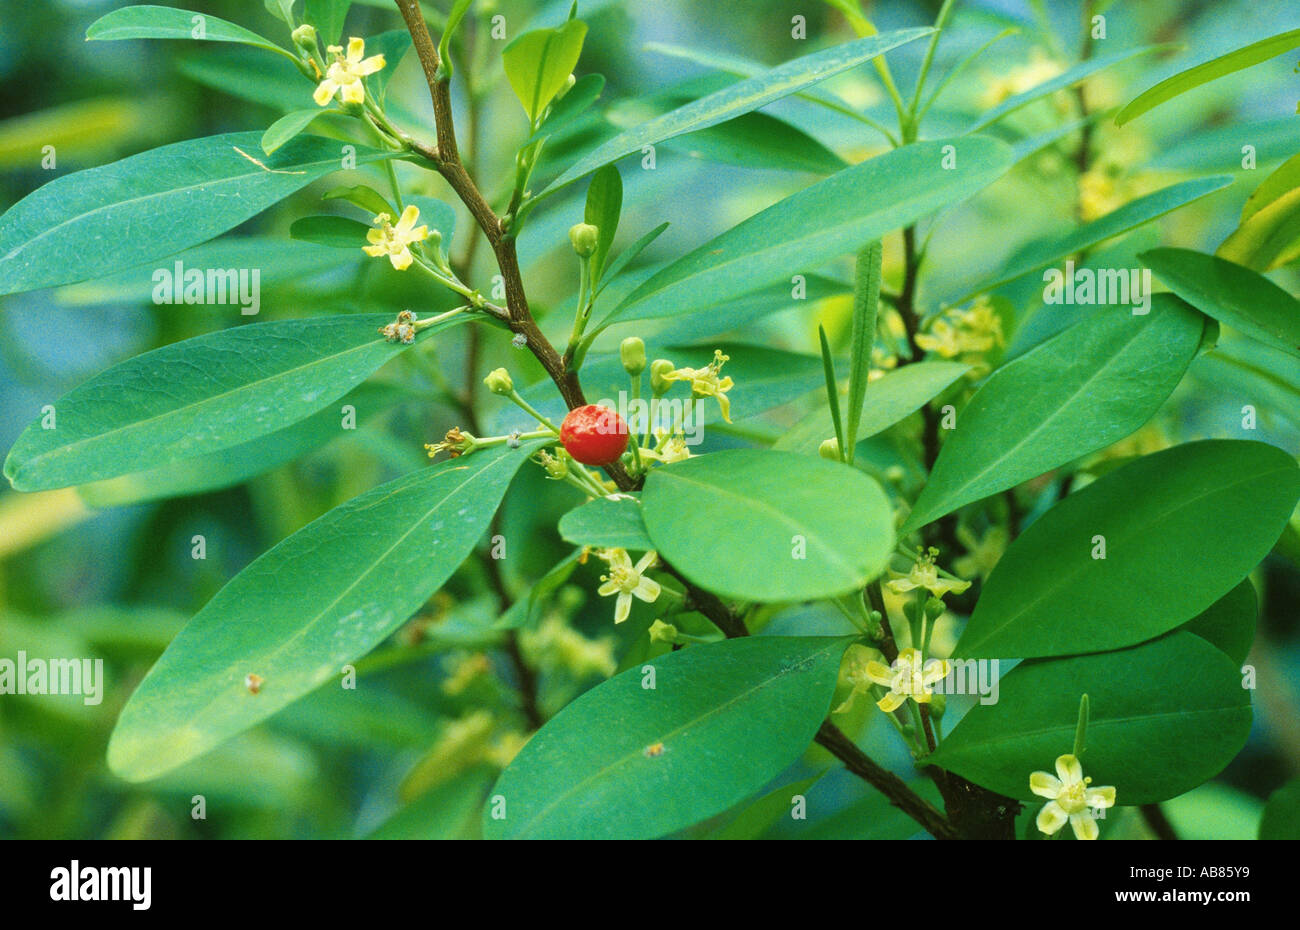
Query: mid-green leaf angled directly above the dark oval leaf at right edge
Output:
[[900, 294, 1204, 533]]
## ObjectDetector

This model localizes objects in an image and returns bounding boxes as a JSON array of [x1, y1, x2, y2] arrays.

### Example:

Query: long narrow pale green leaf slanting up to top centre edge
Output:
[[534, 29, 935, 200]]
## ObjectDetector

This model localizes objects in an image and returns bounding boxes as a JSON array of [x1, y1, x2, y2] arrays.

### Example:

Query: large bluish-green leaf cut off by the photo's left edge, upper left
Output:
[[0, 133, 394, 294]]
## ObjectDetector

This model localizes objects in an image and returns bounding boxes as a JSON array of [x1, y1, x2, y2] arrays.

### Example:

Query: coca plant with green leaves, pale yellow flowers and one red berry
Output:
[[0, 0, 1300, 839]]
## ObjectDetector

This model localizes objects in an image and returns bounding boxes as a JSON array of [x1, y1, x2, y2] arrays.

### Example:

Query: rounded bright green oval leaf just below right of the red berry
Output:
[[641, 449, 894, 601]]
